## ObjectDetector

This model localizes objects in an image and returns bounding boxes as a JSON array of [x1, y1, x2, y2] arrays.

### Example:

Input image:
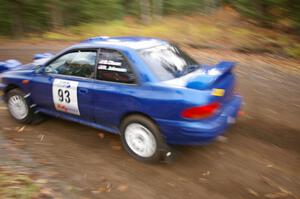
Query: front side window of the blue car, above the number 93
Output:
[[45, 51, 97, 78]]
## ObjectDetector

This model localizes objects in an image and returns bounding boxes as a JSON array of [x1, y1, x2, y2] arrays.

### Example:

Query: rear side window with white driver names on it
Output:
[[97, 49, 135, 83]]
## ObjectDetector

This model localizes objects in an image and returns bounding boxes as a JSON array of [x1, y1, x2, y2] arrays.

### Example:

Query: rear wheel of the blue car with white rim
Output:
[[120, 115, 171, 163]]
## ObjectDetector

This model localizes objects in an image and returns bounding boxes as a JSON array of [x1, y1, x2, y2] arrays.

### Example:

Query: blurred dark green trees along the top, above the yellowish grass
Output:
[[0, 0, 300, 36]]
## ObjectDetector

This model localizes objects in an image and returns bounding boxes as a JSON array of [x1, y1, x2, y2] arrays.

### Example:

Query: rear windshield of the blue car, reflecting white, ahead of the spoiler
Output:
[[140, 45, 200, 81]]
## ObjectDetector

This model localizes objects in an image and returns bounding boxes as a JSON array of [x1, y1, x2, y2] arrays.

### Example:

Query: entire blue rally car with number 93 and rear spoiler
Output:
[[0, 37, 242, 162]]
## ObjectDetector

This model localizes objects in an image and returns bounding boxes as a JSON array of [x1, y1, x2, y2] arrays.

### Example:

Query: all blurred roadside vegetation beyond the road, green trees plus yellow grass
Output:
[[0, 0, 300, 58]]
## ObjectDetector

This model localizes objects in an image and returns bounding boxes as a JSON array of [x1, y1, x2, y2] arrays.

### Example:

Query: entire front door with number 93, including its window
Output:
[[32, 49, 97, 121]]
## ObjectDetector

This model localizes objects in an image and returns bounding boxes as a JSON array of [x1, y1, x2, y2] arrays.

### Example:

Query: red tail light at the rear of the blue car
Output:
[[181, 102, 220, 119]]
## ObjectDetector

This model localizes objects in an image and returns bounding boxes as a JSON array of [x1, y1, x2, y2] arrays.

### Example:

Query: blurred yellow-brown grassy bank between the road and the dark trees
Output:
[[0, 16, 300, 58]]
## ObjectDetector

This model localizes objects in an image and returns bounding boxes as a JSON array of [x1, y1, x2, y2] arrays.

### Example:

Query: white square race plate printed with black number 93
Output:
[[52, 79, 80, 115]]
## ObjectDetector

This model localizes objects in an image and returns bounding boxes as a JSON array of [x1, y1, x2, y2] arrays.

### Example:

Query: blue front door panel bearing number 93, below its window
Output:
[[32, 75, 94, 121]]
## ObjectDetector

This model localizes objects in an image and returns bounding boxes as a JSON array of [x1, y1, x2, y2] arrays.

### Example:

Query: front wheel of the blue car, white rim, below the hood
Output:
[[6, 89, 37, 124]]
